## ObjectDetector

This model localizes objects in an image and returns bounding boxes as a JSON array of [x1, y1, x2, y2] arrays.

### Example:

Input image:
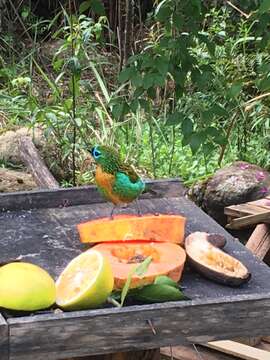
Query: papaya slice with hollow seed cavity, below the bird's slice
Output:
[[92, 241, 186, 289]]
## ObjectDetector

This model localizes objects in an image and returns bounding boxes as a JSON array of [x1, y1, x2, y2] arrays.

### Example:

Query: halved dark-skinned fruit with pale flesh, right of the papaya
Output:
[[185, 232, 251, 286]]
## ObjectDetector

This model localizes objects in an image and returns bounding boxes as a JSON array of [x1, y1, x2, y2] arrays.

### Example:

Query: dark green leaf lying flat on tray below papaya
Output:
[[132, 284, 186, 303]]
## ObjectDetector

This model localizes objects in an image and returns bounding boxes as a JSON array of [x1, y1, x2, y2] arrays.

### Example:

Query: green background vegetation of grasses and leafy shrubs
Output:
[[0, 0, 270, 186]]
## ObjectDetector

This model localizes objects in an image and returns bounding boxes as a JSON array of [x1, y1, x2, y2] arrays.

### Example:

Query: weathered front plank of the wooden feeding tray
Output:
[[8, 293, 270, 360]]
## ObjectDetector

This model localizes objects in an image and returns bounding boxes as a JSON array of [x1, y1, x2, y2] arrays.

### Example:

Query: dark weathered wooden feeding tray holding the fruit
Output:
[[0, 181, 270, 360]]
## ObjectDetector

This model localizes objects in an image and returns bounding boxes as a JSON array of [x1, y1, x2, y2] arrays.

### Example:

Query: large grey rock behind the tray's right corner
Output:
[[189, 161, 270, 225]]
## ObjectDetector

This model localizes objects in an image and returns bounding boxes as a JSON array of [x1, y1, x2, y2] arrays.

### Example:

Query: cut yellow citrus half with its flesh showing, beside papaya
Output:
[[56, 249, 114, 310]]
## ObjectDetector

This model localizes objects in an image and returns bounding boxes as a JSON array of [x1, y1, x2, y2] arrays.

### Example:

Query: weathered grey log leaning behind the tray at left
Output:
[[19, 136, 59, 189]]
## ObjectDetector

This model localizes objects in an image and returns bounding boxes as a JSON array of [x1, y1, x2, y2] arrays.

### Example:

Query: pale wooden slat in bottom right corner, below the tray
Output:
[[206, 340, 270, 360]]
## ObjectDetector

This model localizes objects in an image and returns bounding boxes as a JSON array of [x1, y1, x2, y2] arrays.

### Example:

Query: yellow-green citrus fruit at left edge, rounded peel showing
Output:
[[0, 262, 55, 311]]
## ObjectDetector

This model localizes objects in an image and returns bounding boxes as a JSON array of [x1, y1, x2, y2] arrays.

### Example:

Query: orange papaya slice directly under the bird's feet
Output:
[[77, 214, 186, 244]]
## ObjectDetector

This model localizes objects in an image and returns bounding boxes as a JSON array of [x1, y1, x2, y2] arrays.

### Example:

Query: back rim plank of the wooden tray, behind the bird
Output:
[[0, 179, 186, 212]]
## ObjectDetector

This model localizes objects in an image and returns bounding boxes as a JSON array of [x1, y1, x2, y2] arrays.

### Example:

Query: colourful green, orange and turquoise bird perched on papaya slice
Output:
[[91, 145, 145, 217]]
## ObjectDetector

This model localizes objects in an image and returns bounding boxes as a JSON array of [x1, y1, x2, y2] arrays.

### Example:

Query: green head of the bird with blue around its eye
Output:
[[91, 145, 121, 173]]
